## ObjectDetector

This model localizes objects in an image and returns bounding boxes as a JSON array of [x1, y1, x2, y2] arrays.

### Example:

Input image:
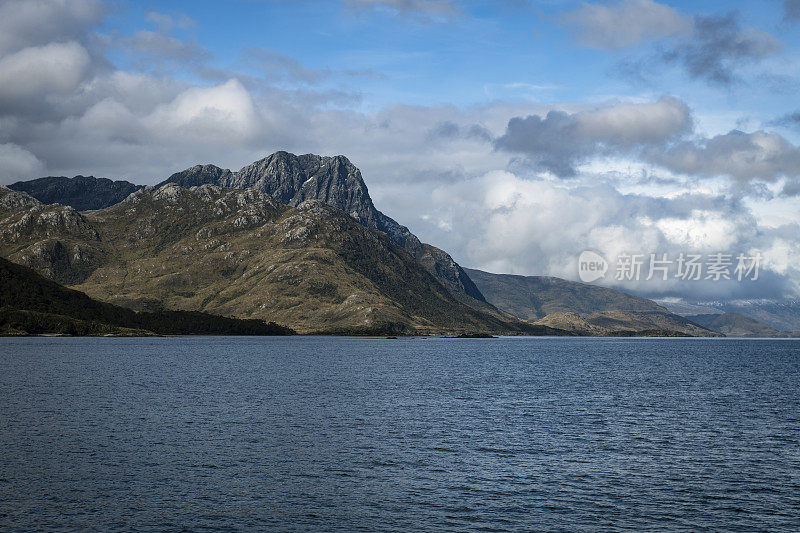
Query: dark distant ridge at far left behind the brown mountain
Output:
[[8, 176, 142, 211]]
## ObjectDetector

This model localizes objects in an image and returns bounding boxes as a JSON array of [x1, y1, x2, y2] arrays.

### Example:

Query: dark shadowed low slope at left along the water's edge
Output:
[[0, 257, 293, 335]]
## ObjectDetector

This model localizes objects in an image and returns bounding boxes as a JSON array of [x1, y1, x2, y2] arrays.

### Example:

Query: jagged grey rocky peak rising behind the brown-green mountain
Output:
[[156, 152, 487, 304]]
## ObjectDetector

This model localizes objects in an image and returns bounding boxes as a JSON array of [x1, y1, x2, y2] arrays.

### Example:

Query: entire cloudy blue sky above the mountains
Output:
[[0, 0, 800, 301]]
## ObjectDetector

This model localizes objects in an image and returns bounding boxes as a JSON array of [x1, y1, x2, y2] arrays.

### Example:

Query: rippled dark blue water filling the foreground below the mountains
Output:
[[0, 337, 800, 531]]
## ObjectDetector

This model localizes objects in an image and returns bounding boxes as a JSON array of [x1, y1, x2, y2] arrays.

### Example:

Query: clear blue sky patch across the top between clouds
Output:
[[102, 0, 800, 120]]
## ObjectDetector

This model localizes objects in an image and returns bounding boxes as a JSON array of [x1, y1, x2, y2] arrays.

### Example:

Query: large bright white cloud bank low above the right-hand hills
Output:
[[400, 171, 800, 299]]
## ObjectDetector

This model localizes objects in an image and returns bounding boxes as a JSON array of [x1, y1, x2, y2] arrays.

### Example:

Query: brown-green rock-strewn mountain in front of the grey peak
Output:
[[0, 184, 560, 334]]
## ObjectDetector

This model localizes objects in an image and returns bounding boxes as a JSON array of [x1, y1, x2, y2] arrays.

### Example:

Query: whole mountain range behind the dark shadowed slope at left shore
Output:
[[0, 152, 792, 336]]
